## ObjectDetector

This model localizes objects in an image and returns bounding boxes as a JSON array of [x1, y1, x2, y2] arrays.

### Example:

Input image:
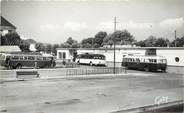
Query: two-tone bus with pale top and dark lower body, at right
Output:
[[122, 55, 167, 72]]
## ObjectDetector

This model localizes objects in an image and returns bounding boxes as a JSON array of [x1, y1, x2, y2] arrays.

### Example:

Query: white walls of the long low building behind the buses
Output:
[[57, 48, 184, 66]]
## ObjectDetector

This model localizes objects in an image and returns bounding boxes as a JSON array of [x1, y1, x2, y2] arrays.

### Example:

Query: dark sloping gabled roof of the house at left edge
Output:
[[0, 16, 16, 30]]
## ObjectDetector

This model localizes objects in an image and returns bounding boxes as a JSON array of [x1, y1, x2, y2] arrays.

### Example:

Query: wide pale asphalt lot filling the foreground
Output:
[[0, 68, 184, 113]]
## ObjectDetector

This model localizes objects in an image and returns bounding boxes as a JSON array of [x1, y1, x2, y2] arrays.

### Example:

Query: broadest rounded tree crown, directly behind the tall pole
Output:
[[103, 30, 135, 45]]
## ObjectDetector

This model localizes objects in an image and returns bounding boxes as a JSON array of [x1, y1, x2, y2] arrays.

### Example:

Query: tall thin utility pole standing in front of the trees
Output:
[[113, 17, 117, 74]]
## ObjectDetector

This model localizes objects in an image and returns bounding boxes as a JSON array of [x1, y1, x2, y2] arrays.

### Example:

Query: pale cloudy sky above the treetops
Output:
[[0, 0, 184, 44]]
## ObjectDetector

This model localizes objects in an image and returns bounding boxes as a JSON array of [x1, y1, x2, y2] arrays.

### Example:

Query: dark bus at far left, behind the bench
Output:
[[0, 52, 56, 69]]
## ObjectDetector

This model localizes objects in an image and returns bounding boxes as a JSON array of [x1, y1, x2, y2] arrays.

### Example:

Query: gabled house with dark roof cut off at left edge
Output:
[[0, 16, 16, 45]]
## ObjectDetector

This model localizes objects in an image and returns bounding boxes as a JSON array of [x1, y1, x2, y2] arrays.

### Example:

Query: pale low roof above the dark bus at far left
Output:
[[0, 46, 21, 53]]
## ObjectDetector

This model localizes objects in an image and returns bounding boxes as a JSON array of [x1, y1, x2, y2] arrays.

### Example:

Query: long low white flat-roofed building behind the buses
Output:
[[57, 47, 184, 66]]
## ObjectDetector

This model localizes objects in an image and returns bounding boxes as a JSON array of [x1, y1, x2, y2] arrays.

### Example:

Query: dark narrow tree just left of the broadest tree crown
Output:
[[93, 31, 107, 48]]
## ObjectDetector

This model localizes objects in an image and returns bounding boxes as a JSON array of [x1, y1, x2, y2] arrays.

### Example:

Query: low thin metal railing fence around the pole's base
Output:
[[66, 67, 126, 75]]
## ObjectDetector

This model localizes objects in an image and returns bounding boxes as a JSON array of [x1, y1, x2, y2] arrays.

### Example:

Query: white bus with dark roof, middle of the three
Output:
[[76, 53, 106, 66]]
